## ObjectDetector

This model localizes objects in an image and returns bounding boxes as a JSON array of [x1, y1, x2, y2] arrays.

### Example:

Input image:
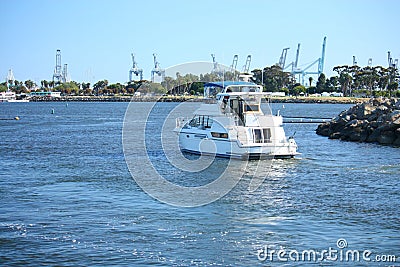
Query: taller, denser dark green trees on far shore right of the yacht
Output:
[[252, 65, 400, 97]]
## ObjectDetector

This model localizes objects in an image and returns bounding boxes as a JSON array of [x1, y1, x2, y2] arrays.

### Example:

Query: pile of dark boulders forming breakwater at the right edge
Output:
[[316, 99, 400, 146]]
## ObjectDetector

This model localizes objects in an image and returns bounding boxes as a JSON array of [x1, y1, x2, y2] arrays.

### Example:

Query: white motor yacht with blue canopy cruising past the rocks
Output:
[[174, 81, 298, 160]]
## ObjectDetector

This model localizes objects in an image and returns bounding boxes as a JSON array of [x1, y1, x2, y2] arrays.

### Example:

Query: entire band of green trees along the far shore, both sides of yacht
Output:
[[0, 65, 400, 97]]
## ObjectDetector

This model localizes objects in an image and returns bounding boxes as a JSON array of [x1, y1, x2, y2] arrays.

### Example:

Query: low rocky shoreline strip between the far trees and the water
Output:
[[26, 96, 370, 104]]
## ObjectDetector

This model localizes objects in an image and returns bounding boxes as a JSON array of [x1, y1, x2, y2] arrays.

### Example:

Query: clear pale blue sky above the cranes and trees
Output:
[[0, 0, 400, 84]]
